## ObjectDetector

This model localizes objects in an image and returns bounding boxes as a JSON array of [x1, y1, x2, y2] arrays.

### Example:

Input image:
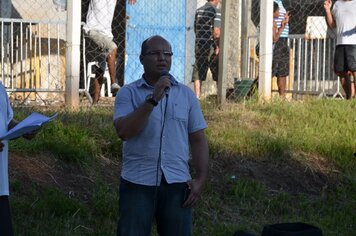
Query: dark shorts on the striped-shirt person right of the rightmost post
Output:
[[272, 38, 289, 77]]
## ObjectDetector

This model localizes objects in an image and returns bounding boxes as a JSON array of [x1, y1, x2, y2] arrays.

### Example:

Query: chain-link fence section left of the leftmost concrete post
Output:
[[0, 0, 66, 103]]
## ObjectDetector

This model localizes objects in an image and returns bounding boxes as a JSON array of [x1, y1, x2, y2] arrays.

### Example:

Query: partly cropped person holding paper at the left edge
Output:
[[0, 82, 36, 236]]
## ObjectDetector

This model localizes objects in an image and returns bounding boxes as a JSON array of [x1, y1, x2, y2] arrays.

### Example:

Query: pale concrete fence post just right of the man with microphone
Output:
[[218, 1, 231, 104]]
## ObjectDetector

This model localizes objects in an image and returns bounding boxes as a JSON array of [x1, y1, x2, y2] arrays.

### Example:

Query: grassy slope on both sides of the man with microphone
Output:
[[10, 99, 356, 236]]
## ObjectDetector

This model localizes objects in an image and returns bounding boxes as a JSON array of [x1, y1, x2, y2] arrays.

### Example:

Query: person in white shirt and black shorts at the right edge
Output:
[[324, 0, 356, 99]]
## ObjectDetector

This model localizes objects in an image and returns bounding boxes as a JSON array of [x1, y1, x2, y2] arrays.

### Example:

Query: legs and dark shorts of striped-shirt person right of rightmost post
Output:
[[272, 38, 289, 98]]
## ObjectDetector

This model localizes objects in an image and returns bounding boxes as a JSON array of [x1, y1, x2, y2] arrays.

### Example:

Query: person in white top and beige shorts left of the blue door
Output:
[[83, 0, 136, 103]]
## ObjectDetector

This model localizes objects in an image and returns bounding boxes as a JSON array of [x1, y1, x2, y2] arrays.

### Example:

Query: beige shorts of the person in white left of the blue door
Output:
[[87, 30, 117, 71]]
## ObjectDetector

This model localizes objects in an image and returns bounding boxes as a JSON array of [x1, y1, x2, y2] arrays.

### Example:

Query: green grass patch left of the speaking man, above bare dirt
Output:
[[11, 108, 121, 166]]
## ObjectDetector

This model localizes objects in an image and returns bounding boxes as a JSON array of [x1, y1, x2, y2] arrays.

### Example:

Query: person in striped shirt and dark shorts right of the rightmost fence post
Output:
[[272, 0, 289, 98]]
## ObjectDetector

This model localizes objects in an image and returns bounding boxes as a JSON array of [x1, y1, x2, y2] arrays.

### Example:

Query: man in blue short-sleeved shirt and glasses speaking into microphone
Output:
[[114, 35, 209, 236]]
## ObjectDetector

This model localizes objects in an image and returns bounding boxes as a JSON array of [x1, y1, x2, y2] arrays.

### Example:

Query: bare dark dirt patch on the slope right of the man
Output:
[[209, 152, 338, 195]]
